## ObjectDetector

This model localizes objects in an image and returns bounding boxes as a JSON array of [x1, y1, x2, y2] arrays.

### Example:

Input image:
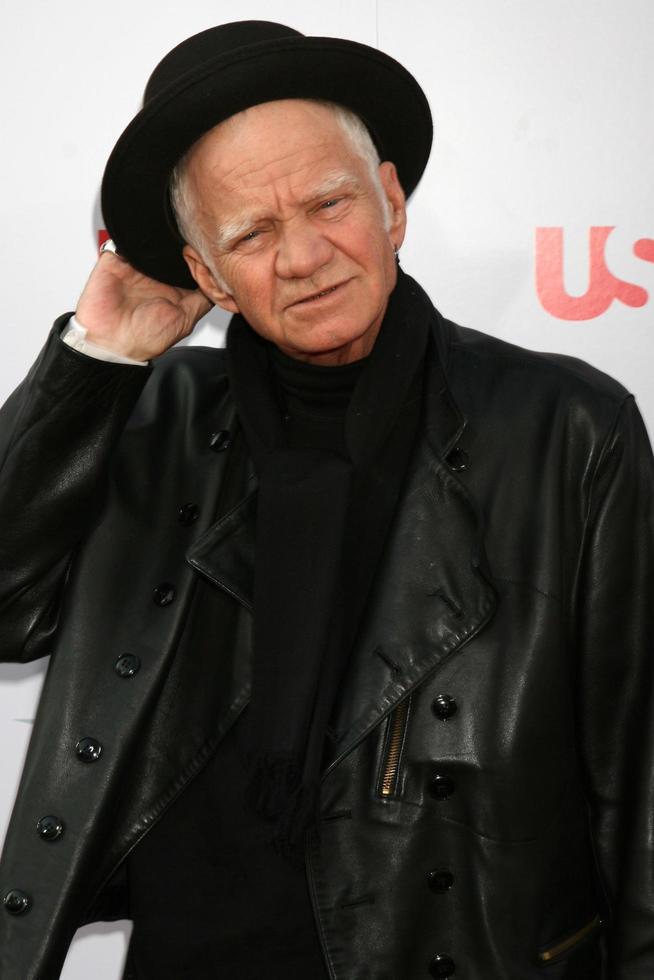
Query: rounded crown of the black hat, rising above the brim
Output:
[[143, 20, 304, 104]]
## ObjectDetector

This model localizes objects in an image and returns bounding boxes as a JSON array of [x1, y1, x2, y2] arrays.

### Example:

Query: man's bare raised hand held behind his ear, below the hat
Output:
[[76, 250, 213, 361]]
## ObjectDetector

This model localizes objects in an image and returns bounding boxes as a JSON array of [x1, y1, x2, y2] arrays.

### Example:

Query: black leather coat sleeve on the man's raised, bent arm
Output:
[[0, 316, 151, 661]]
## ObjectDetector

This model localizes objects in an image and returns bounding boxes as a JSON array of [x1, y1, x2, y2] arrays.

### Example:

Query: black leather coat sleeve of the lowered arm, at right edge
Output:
[[576, 397, 654, 980]]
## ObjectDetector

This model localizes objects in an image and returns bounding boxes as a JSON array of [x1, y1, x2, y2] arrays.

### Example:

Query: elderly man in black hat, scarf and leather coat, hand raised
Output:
[[0, 22, 654, 980]]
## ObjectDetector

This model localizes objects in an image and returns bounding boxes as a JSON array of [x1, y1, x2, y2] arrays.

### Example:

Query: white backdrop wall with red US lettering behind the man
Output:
[[0, 0, 654, 980]]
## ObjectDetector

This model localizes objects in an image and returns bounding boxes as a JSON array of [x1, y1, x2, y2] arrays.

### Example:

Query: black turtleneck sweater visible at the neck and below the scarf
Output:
[[123, 347, 365, 980]]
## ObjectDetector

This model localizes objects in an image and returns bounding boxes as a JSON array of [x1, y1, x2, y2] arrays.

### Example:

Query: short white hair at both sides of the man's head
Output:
[[168, 99, 391, 286]]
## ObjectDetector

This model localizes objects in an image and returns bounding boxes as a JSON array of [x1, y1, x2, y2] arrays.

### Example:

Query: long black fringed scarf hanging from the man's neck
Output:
[[227, 272, 430, 856]]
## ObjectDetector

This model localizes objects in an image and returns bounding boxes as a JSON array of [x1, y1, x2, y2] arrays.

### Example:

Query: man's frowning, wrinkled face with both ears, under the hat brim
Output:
[[179, 99, 406, 364]]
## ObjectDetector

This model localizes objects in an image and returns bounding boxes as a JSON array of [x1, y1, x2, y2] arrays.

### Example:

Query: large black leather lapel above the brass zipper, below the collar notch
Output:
[[327, 428, 495, 771]]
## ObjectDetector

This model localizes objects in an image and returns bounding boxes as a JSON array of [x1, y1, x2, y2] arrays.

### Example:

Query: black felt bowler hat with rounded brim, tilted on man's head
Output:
[[102, 20, 432, 288]]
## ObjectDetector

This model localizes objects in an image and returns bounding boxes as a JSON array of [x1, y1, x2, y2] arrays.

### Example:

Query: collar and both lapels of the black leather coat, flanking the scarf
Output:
[[187, 290, 495, 770]]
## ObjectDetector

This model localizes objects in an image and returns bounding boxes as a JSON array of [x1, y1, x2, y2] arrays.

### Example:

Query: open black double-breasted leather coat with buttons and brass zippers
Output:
[[0, 280, 654, 980]]
